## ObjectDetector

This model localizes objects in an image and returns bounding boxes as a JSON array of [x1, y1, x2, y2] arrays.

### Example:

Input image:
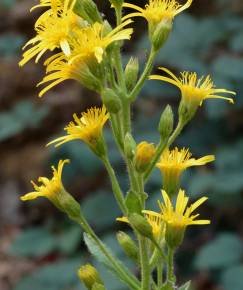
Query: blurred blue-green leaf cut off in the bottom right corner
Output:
[[221, 265, 243, 290]]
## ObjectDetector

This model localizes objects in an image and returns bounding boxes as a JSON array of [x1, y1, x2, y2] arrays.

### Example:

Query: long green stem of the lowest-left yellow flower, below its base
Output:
[[79, 214, 140, 290]]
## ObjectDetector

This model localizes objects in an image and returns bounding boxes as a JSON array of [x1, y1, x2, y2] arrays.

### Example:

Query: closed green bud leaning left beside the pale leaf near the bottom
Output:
[[116, 231, 138, 262]]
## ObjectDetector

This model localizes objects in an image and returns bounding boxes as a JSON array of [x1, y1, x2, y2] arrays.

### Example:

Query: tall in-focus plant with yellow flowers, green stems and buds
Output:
[[19, 0, 235, 290]]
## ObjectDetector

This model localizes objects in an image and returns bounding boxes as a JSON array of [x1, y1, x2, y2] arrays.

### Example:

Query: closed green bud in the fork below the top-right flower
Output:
[[125, 57, 139, 91]]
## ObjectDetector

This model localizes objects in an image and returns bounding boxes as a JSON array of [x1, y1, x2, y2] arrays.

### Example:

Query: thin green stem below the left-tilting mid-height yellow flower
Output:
[[102, 157, 127, 215]]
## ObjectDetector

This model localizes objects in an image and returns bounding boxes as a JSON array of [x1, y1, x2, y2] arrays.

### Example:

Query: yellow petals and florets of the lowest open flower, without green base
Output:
[[159, 189, 210, 229]]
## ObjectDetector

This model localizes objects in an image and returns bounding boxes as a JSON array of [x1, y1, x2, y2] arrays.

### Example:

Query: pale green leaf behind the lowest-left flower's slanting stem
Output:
[[84, 233, 133, 282]]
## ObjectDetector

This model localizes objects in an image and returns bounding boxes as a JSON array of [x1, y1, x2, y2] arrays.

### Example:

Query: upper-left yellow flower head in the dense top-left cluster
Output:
[[19, 0, 81, 66]]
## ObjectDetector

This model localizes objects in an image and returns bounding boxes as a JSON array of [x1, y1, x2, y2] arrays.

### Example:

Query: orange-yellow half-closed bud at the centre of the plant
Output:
[[134, 141, 156, 173]]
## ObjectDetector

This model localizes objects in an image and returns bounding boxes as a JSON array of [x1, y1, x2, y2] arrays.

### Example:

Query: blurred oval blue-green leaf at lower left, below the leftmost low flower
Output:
[[10, 228, 56, 257]]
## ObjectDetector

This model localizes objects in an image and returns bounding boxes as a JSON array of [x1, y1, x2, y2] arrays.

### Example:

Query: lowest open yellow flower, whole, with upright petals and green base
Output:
[[159, 189, 210, 248]]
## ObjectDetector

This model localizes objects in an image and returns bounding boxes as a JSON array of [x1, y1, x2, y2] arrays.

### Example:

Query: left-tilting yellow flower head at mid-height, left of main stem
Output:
[[47, 106, 109, 148]]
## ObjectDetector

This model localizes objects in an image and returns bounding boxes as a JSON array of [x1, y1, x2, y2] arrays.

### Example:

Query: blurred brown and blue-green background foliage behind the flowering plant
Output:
[[0, 0, 243, 290]]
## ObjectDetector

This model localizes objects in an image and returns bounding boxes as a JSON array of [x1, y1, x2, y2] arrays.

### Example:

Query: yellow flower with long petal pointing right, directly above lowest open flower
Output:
[[156, 147, 215, 196]]
